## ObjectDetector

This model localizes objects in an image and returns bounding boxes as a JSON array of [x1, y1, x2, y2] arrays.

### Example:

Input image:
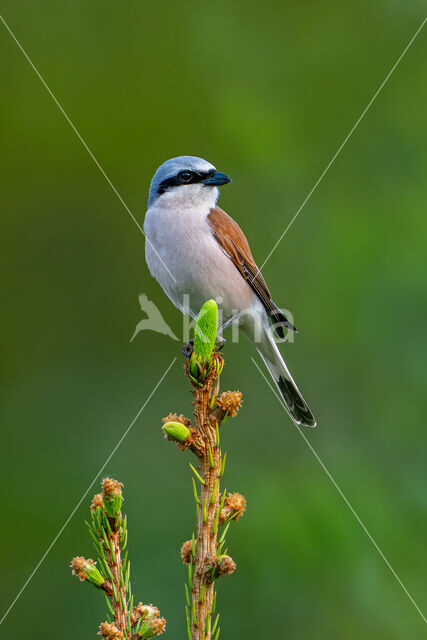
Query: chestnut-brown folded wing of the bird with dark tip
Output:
[[208, 207, 295, 338]]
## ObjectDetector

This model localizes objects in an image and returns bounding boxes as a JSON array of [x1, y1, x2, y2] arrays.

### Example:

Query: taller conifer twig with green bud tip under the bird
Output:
[[163, 301, 246, 640]]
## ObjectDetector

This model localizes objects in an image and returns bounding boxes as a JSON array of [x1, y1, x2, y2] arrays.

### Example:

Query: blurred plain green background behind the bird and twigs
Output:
[[0, 0, 427, 640]]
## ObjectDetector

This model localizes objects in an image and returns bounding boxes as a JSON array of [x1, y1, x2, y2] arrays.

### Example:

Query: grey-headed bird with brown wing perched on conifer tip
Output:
[[144, 156, 316, 427]]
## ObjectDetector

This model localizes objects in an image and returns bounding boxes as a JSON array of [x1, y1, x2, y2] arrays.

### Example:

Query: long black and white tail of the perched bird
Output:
[[257, 327, 316, 427]]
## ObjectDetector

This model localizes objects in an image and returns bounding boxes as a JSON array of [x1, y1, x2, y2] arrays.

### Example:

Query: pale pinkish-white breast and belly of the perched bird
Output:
[[144, 190, 254, 320]]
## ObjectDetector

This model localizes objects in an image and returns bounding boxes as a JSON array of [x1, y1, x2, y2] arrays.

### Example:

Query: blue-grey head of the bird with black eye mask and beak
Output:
[[148, 156, 231, 207]]
